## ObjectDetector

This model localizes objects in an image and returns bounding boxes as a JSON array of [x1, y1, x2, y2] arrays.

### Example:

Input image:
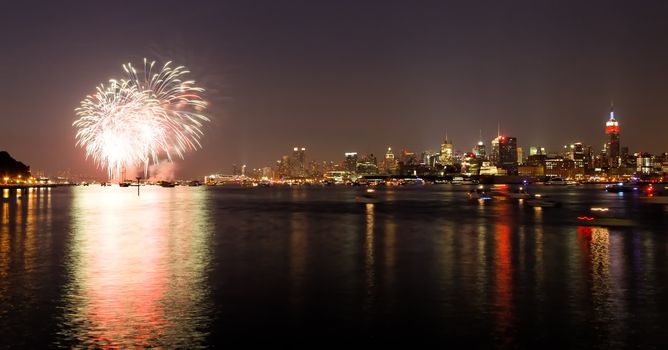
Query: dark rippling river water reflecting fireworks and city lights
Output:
[[0, 185, 668, 349]]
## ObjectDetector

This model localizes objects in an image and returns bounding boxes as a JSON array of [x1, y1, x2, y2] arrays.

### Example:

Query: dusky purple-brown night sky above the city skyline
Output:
[[0, 0, 668, 178]]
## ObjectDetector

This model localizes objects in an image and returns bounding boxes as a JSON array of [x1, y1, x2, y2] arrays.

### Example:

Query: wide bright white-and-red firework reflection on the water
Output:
[[61, 188, 212, 348]]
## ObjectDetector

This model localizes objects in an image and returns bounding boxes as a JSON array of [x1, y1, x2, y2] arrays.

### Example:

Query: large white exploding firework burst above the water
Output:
[[72, 59, 209, 178]]
